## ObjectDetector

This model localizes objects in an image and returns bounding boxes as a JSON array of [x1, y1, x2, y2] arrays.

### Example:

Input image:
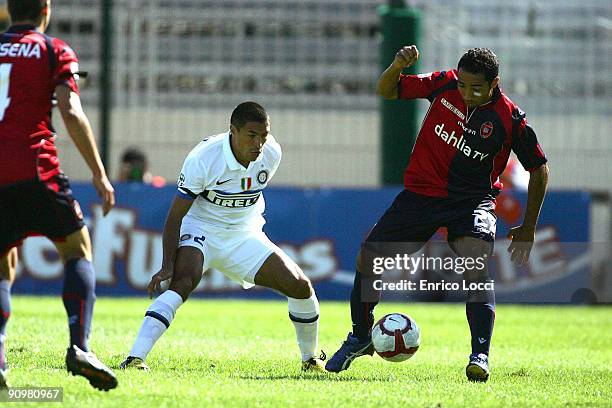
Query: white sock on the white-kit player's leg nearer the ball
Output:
[[287, 293, 319, 361]]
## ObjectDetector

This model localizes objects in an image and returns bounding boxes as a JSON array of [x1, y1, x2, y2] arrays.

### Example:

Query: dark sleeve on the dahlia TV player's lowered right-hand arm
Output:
[[512, 108, 548, 171]]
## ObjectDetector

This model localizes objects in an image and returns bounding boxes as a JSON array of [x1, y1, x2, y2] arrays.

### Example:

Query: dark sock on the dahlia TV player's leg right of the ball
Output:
[[465, 291, 495, 355]]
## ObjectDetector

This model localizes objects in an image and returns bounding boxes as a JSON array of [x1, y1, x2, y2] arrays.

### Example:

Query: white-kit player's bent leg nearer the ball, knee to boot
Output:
[[255, 252, 325, 372]]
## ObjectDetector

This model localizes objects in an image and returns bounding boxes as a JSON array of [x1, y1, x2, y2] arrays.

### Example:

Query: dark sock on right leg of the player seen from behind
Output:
[[62, 258, 96, 351]]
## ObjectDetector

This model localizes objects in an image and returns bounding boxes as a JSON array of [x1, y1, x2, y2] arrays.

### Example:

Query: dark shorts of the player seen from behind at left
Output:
[[0, 174, 85, 256]]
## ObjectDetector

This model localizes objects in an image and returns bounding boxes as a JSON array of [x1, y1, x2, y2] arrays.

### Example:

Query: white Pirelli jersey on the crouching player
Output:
[[178, 132, 282, 231]]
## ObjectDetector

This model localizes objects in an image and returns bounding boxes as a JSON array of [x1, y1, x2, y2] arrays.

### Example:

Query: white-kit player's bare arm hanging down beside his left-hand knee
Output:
[[147, 196, 193, 298]]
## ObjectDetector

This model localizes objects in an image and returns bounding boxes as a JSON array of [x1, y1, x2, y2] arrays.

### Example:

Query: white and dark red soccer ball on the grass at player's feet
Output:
[[372, 313, 421, 362]]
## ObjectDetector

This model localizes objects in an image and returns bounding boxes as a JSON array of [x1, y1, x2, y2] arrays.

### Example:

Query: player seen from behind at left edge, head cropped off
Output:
[[0, 0, 117, 390]]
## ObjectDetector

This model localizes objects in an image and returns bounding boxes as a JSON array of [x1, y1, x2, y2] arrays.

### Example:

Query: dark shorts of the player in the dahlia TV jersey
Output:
[[366, 190, 497, 252]]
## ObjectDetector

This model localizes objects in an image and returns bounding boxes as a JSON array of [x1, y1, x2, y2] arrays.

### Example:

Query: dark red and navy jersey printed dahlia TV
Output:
[[398, 70, 546, 197]]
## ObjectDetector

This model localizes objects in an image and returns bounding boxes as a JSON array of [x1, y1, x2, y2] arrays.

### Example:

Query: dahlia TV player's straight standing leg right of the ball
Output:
[[451, 236, 495, 382]]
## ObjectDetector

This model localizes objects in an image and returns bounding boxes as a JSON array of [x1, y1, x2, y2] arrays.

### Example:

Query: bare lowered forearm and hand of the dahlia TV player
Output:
[[508, 164, 549, 265]]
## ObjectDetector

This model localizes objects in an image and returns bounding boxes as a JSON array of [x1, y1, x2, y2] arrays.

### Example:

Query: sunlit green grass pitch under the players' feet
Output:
[[1, 296, 612, 408]]
